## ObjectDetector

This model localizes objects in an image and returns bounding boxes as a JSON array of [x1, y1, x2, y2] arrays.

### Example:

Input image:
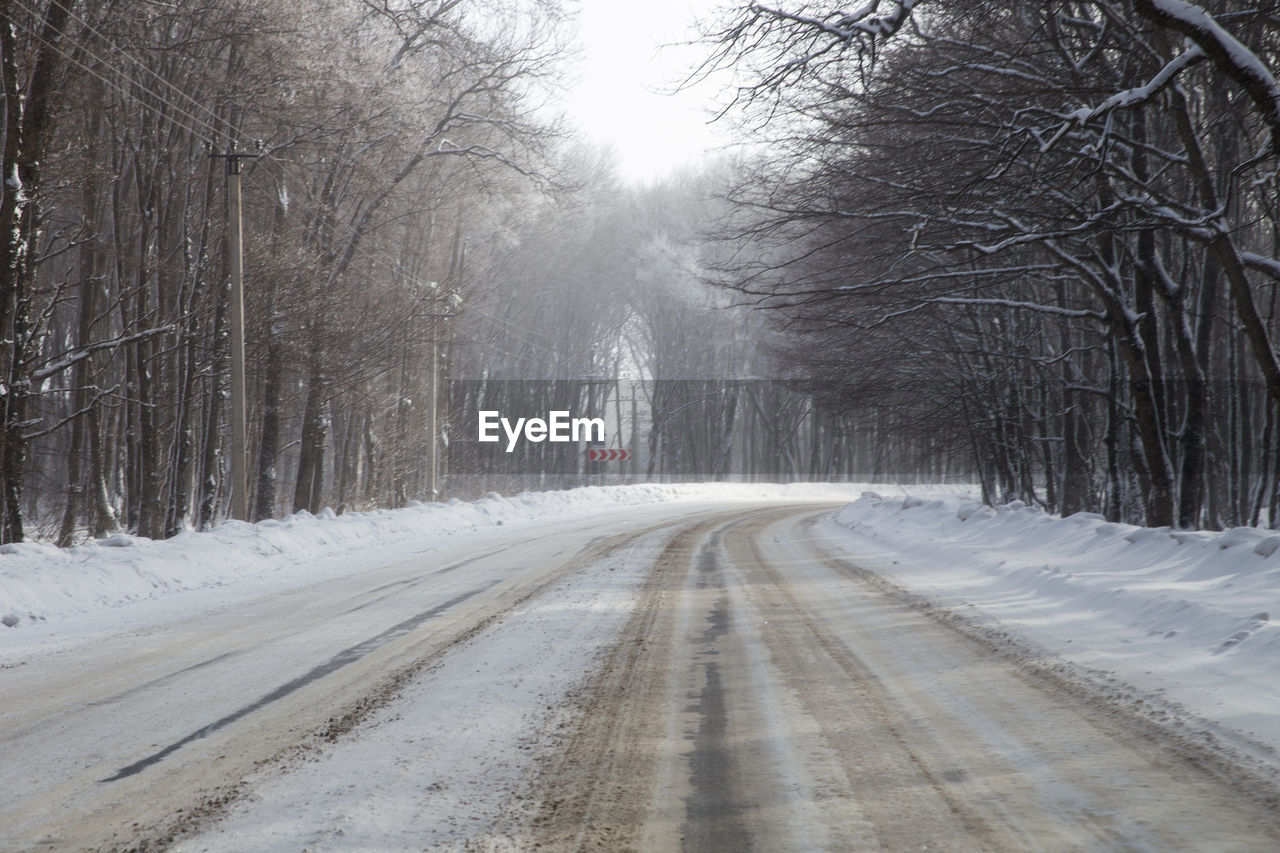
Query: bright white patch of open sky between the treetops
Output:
[[564, 0, 723, 182]]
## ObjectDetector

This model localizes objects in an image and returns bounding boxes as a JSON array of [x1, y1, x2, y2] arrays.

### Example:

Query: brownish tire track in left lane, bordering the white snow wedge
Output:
[[0, 514, 721, 852]]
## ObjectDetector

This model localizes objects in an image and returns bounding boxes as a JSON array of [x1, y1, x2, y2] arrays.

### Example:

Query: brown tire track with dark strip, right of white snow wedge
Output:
[[519, 507, 839, 853]]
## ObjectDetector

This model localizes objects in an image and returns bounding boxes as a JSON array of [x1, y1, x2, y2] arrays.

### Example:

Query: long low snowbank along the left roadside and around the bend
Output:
[[0, 483, 865, 628]]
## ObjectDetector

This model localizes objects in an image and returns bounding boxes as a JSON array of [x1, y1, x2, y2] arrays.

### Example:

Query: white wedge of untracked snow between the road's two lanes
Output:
[[184, 534, 666, 853]]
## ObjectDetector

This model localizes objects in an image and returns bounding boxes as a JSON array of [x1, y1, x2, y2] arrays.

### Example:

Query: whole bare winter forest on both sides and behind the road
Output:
[[0, 0, 1280, 546]]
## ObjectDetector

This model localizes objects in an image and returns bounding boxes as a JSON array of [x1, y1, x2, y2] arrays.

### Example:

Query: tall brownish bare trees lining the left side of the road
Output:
[[0, 0, 563, 544]]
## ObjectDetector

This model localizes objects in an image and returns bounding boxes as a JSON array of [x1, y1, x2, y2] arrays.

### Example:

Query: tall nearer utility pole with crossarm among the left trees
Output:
[[210, 151, 257, 521]]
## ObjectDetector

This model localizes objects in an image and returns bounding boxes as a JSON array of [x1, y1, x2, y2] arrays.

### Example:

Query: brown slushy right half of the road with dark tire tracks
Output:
[[511, 508, 1280, 853]]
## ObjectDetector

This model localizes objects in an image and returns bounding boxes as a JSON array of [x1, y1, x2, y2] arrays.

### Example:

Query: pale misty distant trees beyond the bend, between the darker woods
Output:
[[443, 166, 973, 497]]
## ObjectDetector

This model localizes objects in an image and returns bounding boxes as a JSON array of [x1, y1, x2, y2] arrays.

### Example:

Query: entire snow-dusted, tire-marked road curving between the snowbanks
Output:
[[0, 505, 1280, 852]]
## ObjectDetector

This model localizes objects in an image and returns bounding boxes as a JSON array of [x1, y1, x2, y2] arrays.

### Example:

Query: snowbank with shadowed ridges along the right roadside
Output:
[[836, 493, 1280, 749]]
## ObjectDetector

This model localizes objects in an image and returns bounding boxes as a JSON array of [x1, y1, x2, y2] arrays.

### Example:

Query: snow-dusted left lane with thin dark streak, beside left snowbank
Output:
[[0, 494, 773, 850]]
